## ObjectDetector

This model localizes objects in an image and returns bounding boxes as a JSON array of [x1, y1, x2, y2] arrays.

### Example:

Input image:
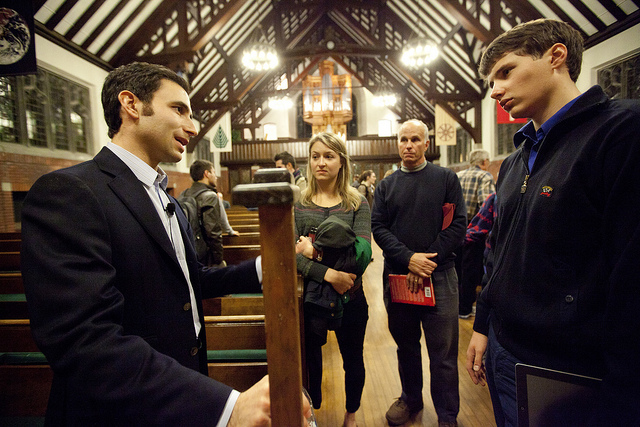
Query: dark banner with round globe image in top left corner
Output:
[[0, 0, 38, 76]]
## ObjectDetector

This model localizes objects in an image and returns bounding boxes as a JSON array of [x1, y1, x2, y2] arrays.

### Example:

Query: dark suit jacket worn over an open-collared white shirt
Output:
[[21, 148, 260, 426]]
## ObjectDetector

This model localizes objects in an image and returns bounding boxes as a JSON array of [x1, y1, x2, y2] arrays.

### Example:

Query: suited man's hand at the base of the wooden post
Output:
[[227, 375, 271, 427]]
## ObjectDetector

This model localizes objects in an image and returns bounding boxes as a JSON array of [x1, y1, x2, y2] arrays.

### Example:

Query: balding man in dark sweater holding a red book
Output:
[[371, 120, 467, 427]]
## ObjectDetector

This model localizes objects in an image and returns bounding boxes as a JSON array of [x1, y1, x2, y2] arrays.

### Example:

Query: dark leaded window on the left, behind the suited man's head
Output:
[[0, 68, 91, 153]]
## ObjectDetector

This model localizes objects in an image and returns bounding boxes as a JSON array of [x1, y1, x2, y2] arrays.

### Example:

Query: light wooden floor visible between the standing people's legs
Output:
[[316, 243, 496, 427]]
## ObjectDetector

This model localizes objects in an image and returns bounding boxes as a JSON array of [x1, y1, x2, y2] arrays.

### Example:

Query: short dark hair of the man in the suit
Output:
[[102, 62, 189, 138]]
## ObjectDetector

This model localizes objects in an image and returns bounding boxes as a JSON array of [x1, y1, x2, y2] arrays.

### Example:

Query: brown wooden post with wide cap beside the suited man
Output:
[[233, 169, 303, 426]]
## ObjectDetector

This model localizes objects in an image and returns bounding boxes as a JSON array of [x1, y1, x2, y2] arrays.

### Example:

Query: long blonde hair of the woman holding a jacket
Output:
[[300, 132, 362, 211]]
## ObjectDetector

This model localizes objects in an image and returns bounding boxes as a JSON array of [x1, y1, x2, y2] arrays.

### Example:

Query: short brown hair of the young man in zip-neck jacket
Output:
[[478, 19, 584, 82]]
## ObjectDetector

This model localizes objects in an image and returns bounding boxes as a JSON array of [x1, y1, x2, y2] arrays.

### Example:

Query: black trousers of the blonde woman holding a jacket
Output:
[[305, 293, 369, 412]]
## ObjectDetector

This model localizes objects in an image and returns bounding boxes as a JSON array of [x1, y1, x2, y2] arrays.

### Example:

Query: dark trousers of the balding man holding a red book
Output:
[[387, 267, 460, 422]]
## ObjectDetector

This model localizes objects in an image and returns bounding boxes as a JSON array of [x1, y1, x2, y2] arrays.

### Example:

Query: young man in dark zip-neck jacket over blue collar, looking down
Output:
[[466, 19, 640, 426]]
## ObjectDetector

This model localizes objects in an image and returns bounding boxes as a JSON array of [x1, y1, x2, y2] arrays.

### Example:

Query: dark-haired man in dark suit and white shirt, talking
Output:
[[22, 63, 302, 426]]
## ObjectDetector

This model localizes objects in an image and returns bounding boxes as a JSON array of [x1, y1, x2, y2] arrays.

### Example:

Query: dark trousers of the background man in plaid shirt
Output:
[[457, 240, 485, 314]]
